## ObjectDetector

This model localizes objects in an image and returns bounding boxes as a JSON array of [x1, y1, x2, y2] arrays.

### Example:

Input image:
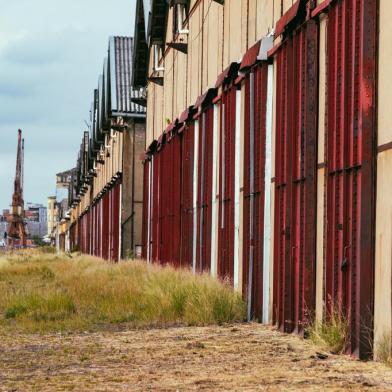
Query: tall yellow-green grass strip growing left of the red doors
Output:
[[0, 251, 245, 332]]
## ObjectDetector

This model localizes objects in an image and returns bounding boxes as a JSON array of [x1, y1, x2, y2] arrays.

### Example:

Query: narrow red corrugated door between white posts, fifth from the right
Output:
[[196, 106, 214, 272]]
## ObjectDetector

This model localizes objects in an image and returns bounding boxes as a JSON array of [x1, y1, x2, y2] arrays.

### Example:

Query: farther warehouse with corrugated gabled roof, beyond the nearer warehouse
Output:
[[58, 37, 146, 261]]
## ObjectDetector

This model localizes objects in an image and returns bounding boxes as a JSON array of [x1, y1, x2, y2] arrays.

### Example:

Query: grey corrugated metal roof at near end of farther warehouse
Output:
[[107, 37, 146, 117]]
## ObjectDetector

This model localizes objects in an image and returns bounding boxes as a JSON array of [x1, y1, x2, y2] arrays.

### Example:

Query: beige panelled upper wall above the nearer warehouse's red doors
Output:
[[146, 0, 294, 146]]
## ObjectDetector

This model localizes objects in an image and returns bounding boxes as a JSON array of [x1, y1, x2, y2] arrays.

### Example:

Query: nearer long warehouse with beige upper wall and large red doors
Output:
[[133, 0, 392, 358]]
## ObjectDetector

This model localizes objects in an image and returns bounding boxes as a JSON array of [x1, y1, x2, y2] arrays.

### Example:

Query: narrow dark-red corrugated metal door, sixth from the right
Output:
[[180, 123, 195, 268]]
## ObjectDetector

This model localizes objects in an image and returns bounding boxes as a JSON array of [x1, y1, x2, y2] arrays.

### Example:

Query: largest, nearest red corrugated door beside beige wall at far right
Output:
[[325, 0, 378, 358]]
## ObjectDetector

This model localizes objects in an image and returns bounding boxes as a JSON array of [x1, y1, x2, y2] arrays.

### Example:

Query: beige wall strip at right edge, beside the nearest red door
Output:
[[374, 0, 392, 348]]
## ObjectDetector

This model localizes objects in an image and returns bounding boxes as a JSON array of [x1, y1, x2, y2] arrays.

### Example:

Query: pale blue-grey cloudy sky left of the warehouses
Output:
[[0, 0, 136, 209]]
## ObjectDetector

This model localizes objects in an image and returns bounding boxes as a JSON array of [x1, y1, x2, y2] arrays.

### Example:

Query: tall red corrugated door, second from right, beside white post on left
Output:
[[274, 20, 318, 332]]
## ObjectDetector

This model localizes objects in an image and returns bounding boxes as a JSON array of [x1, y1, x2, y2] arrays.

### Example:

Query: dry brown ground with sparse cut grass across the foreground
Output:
[[0, 324, 392, 392]]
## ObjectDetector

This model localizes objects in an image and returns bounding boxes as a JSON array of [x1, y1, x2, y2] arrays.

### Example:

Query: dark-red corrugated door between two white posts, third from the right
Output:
[[242, 65, 268, 321]]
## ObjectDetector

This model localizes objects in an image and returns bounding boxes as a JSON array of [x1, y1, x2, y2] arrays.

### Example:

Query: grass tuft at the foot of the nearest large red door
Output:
[[308, 307, 348, 354]]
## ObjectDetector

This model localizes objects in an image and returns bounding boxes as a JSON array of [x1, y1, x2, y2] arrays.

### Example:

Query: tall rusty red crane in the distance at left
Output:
[[8, 129, 26, 248]]
